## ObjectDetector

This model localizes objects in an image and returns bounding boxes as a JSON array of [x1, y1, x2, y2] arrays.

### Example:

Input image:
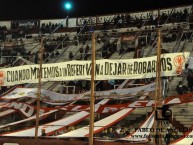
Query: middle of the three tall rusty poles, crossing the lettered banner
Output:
[[89, 32, 95, 145]]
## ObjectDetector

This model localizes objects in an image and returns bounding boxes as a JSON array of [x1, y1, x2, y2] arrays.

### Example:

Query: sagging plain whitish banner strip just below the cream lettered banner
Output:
[[0, 83, 155, 102]]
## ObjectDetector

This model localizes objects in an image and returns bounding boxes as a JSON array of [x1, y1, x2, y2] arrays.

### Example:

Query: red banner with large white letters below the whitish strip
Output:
[[0, 92, 193, 117]]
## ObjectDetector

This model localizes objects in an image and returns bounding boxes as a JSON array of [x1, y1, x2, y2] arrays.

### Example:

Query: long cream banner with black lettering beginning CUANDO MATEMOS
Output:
[[0, 52, 190, 86]]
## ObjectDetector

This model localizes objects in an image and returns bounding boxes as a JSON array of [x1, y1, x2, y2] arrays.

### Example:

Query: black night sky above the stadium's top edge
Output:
[[0, 0, 193, 20]]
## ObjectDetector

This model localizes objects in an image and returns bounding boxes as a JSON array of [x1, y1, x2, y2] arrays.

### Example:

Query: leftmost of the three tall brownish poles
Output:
[[35, 39, 43, 139]]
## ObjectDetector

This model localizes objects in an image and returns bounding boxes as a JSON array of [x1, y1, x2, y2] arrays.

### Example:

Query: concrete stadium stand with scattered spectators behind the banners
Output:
[[0, 6, 193, 145]]
